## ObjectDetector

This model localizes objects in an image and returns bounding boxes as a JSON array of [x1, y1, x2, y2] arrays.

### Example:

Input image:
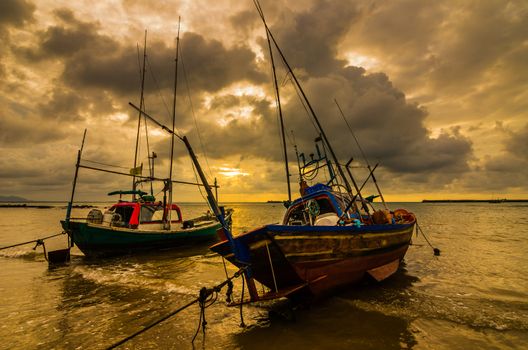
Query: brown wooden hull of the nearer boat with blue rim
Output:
[[211, 223, 414, 297]]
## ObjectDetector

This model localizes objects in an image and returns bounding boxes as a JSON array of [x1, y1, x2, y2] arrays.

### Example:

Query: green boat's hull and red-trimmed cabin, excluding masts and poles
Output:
[[61, 191, 232, 256]]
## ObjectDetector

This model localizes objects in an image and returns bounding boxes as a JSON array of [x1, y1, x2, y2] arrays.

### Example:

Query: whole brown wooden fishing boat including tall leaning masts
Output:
[[211, 0, 416, 302]]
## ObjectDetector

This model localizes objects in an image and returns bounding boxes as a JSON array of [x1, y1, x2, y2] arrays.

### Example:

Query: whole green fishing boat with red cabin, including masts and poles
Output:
[[61, 26, 233, 256]]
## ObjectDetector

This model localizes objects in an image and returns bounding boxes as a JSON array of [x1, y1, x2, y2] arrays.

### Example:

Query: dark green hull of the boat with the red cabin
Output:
[[61, 221, 220, 256]]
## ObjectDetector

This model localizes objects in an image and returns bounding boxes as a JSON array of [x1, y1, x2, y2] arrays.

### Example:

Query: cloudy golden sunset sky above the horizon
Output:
[[0, 0, 528, 202]]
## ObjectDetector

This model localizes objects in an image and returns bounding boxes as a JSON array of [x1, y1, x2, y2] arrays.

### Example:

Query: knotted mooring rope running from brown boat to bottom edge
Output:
[[106, 267, 247, 350]]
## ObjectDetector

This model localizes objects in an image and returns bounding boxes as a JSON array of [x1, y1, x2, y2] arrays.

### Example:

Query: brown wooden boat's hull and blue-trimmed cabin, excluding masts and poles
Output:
[[211, 184, 416, 301]]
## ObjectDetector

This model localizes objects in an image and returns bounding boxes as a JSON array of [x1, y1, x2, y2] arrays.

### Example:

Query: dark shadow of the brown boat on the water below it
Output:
[[234, 269, 418, 349]]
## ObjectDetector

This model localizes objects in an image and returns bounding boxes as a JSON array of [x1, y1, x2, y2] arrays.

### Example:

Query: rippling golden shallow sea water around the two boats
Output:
[[0, 203, 528, 349]]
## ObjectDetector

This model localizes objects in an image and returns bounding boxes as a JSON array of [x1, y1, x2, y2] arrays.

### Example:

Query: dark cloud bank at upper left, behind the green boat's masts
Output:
[[19, 9, 264, 95]]
